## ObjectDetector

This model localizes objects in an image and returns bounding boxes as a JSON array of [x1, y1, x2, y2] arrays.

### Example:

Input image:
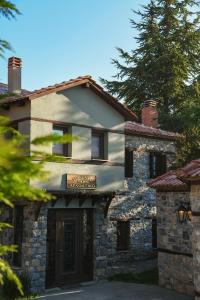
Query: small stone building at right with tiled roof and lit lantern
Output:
[[149, 159, 200, 300]]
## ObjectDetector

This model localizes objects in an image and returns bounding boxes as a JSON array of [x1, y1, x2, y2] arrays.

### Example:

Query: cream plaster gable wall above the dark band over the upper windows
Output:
[[31, 87, 124, 129]]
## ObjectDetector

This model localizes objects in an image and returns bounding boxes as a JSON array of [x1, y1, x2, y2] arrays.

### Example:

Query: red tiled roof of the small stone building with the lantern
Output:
[[148, 159, 200, 190]]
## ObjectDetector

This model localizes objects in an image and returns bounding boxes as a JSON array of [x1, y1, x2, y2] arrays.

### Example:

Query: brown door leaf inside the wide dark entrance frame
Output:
[[55, 210, 82, 285]]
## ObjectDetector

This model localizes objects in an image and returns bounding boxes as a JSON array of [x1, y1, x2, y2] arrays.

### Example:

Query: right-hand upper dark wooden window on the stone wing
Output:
[[149, 152, 167, 178]]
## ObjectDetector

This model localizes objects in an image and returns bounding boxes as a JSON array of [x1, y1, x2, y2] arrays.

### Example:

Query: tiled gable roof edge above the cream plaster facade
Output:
[[0, 75, 137, 121]]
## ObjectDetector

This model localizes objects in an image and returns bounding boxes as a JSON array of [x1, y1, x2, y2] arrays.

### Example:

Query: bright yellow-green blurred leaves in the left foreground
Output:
[[0, 117, 72, 299]]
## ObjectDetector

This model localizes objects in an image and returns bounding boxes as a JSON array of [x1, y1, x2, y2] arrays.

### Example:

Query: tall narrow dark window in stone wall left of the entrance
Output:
[[13, 206, 24, 267]]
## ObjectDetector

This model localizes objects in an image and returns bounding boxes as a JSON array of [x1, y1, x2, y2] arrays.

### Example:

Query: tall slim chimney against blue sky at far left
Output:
[[8, 57, 22, 94]]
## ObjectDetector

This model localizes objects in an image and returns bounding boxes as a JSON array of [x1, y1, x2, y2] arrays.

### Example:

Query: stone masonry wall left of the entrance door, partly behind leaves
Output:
[[1, 203, 47, 293]]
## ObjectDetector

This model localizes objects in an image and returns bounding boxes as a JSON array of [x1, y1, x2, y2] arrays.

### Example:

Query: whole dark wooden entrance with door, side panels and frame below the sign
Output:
[[46, 209, 93, 287]]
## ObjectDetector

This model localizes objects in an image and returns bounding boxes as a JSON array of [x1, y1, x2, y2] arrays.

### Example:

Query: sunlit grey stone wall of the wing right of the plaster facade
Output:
[[105, 136, 176, 268]]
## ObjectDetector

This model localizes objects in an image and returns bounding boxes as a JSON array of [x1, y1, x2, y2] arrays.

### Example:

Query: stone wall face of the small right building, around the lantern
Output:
[[157, 192, 194, 295]]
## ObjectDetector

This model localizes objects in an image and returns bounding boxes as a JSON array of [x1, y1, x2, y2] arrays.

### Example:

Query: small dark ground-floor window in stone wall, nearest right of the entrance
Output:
[[117, 221, 130, 251]]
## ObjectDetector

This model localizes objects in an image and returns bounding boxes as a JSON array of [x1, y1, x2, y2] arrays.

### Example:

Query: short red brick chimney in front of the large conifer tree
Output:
[[142, 100, 158, 128]]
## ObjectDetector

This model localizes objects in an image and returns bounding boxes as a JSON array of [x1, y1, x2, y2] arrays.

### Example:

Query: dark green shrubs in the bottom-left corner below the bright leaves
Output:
[[1, 272, 32, 300]]
